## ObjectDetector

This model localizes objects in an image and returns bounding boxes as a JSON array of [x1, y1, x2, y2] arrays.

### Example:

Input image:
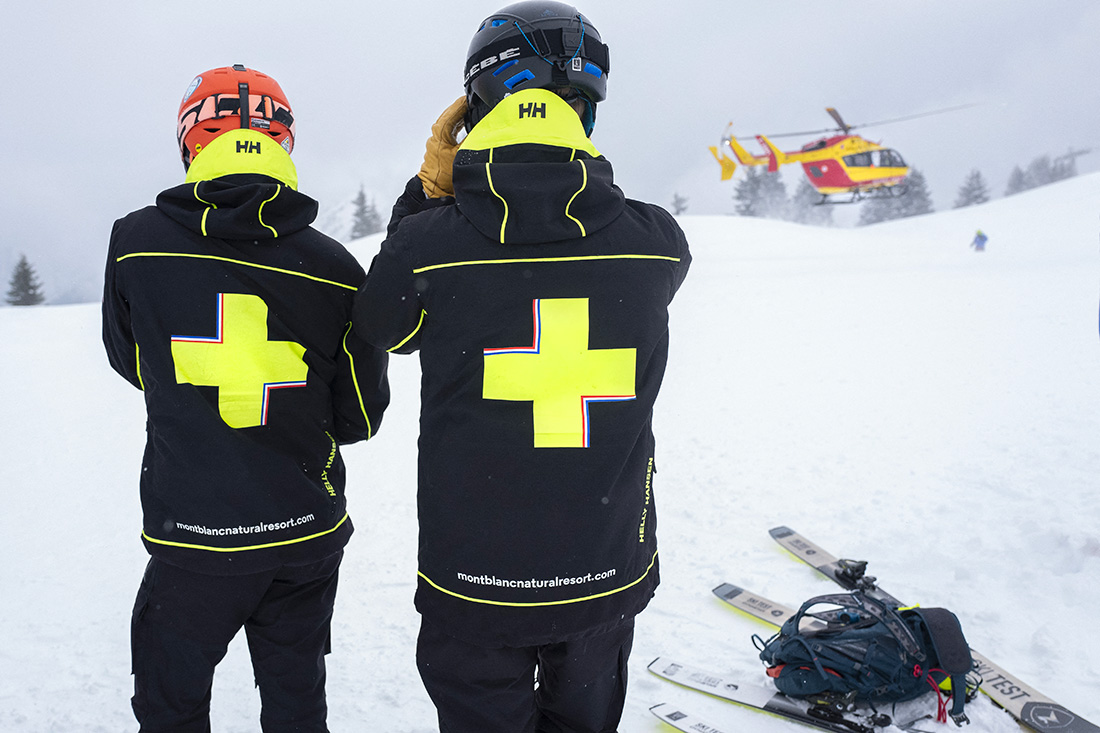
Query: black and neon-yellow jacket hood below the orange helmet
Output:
[[156, 130, 317, 240]]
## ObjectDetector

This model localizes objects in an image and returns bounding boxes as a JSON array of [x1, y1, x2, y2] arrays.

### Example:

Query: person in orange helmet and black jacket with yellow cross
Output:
[[102, 65, 389, 732]]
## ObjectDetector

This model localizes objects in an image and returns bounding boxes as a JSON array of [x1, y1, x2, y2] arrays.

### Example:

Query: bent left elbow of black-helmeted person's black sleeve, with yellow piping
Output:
[[352, 238, 428, 353]]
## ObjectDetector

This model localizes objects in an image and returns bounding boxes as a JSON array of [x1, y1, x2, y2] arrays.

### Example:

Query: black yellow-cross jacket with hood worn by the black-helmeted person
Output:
[[355, 89, 690, 646]]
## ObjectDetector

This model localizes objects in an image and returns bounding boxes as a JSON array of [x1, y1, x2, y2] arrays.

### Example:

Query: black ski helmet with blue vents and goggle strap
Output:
[[463, 0, 611, 134]]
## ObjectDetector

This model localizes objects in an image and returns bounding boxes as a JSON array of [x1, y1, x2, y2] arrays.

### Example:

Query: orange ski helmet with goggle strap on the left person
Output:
[[176, 64, 295, 169]]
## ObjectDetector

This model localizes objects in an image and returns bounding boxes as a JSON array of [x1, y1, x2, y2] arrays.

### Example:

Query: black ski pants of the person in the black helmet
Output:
[[417, 619, 634, 733]]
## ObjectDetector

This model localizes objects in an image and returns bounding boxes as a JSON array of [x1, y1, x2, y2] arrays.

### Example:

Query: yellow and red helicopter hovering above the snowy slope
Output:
[[711, 105, 969, 204]]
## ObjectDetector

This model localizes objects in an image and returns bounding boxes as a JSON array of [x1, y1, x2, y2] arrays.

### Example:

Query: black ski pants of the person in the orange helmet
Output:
[[131, 553, 343, 733]]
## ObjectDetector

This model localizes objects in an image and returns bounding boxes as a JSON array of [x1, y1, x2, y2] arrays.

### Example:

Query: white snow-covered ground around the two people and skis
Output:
[[0, 175, 1100, 733]]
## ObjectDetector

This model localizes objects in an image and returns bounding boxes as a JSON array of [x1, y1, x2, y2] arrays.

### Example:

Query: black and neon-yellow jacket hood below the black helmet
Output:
[[454, 89, 625, 244]]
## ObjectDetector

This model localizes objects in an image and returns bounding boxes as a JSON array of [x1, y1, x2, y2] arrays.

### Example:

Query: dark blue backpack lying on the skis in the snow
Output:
[[754, 590, 980, 725]]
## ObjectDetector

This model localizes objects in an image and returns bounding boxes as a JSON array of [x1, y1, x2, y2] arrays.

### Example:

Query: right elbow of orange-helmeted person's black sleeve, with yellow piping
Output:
[[332, 324, 389, 444]]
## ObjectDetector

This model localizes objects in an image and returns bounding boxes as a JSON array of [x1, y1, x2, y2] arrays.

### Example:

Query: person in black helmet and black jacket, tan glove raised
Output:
[[353, 0, 691, 733]]
